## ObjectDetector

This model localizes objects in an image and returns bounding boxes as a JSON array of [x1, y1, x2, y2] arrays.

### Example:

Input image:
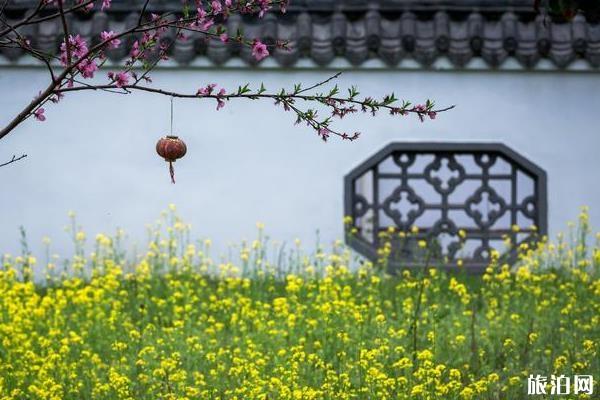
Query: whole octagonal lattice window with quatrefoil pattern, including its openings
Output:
[[345, 143, 547, 272]]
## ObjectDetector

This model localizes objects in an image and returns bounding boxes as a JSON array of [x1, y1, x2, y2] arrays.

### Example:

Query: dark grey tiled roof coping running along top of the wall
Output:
[[2, 0, 600, 69]]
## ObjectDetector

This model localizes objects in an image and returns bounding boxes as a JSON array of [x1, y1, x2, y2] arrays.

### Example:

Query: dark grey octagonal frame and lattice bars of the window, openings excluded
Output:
[[344, 142, 548, 273]]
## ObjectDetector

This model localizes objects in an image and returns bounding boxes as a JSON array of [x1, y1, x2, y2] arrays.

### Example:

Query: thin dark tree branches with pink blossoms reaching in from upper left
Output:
[[0, 0, 454, 146]]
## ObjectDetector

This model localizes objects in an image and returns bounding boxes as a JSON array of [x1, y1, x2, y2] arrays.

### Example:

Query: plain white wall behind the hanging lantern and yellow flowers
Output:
[[0, 68, 600, 255]]
